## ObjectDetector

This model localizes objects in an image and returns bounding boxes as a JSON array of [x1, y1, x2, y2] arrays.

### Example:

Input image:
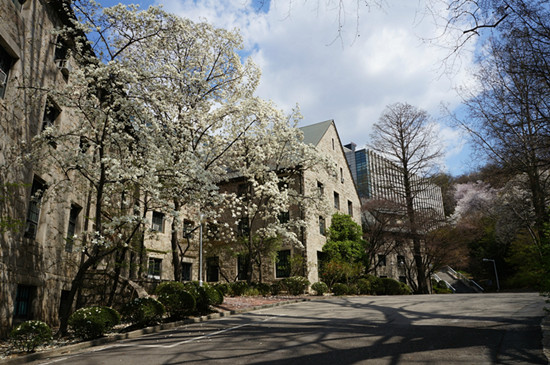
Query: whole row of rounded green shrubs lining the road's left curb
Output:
[[10, 275, 412, 352]]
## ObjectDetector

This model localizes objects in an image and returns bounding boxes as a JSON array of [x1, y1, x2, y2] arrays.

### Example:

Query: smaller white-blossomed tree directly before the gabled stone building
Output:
[[213, 105, 334, 281]]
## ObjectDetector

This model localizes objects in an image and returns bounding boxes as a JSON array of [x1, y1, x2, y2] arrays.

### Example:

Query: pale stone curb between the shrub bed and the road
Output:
[[0, 298, 311, 365]]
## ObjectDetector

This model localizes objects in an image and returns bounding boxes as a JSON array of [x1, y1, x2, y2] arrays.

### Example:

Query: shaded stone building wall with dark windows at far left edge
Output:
[[0, 0, 86, 335]]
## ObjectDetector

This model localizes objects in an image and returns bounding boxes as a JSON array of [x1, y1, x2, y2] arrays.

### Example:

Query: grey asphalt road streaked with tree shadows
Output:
[[36, 293, 547, 365]]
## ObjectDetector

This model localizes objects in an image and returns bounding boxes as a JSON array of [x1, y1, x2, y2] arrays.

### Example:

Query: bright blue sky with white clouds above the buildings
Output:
[[98, 0, 484, 175]]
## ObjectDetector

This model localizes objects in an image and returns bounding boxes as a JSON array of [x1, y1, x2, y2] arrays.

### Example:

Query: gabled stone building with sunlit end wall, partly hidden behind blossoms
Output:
[[205, 120, 361, 283]]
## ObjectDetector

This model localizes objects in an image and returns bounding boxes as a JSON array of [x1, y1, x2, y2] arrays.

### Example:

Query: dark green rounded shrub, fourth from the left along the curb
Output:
[[155, 281, 196, 318]]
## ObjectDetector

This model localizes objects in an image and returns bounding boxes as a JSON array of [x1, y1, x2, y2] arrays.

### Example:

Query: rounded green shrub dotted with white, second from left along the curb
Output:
[[68, 307, 120, 340]]
